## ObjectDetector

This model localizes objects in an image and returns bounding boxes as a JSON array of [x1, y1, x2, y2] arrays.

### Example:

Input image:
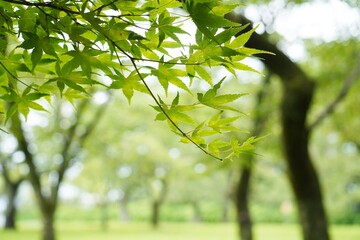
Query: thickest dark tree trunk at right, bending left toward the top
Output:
[[228, 14, 330, 240]]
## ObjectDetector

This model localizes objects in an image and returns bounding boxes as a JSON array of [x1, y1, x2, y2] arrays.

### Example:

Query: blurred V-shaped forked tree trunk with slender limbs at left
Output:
[[11, 101, 105, 240]]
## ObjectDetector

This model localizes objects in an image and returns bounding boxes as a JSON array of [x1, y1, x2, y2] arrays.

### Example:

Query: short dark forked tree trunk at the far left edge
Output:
[[4, 180, 22, 230]]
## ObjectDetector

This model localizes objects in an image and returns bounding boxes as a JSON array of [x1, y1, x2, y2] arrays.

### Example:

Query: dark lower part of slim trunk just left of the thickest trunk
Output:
[[235, 166, 253, 240]]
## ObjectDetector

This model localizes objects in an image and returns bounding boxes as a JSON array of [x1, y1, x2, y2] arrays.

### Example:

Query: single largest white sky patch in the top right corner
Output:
[[274, 0, 360, 41]]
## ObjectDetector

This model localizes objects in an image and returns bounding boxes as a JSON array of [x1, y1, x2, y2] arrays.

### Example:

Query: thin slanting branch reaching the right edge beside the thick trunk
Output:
[[308, 55, 360, 131]]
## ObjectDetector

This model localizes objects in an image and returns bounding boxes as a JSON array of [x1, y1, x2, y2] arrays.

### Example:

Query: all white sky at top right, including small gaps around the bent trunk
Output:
[[245, 0, 360, 60]]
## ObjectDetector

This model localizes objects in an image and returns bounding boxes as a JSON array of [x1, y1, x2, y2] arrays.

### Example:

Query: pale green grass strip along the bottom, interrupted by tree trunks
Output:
[[0, 221, 360, 240]]
